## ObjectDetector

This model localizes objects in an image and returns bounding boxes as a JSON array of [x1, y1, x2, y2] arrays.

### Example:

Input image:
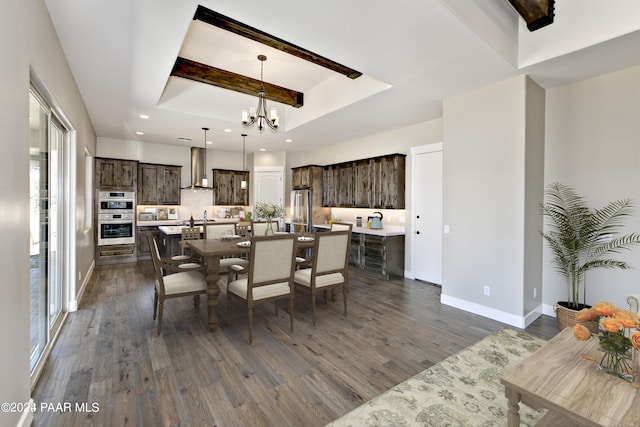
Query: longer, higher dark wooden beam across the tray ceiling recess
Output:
[[193, 6, 362, 79]]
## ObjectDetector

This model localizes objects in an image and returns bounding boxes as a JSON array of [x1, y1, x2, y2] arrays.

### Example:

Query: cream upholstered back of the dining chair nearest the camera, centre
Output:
[[247, 234, 297, 301]]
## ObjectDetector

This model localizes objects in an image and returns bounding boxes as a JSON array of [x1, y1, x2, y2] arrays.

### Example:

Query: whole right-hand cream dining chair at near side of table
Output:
[[294, 230, 351, 325]]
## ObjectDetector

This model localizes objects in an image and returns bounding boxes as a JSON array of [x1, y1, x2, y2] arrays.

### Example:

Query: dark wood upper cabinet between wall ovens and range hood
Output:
[[138, 163, 182, 205]]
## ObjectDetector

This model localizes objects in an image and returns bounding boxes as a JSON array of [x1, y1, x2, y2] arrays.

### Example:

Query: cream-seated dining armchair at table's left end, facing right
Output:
[[146, 232, 207, 335]]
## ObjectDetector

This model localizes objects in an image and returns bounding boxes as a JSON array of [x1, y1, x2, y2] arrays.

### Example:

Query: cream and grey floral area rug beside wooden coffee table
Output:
[[327, 328, 546, 427]]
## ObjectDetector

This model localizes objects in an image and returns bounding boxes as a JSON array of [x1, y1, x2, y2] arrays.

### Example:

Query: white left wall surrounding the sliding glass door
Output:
[[0, 0, 95, 426]]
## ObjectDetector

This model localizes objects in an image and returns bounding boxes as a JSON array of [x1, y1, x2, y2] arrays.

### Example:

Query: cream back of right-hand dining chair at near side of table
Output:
[[311, 230, 351, 276]]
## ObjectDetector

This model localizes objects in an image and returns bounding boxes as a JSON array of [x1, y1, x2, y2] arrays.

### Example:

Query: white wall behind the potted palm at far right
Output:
[[543, 67, 640, 314]]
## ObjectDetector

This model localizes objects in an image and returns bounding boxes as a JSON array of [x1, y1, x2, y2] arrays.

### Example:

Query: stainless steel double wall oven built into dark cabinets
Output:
[[98, 190, 136, 246]]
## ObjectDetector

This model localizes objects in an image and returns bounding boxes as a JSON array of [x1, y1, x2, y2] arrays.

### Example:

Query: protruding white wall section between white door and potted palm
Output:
[[442, 76, 544, 326]]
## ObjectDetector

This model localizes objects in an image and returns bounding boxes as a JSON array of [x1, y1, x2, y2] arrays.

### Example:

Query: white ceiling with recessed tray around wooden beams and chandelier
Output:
[[45, 0, 640, 152]]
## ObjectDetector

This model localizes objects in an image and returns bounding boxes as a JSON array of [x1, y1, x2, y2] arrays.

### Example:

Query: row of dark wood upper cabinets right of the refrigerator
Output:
[[322, 154, 406, 209]]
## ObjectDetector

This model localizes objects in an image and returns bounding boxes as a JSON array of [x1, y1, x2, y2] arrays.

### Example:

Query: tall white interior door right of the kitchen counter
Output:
[[411, 143, 442, 285]]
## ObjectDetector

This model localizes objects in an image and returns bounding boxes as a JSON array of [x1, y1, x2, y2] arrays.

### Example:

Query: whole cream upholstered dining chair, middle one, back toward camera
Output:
[[227, 234, 297, 344]]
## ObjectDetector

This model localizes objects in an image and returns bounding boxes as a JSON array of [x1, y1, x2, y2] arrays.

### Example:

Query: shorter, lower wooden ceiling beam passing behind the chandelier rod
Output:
[[171, 57, 304, 108]]
